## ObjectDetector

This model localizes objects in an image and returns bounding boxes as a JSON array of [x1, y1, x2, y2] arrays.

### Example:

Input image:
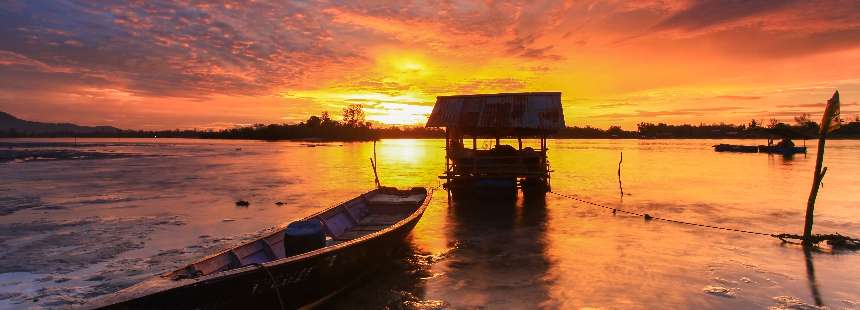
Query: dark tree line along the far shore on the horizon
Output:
[[0, 104, 860, 141]]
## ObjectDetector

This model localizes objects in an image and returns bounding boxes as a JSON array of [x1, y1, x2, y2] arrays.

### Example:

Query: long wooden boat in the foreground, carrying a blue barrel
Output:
[[84, 187, 431, 309]]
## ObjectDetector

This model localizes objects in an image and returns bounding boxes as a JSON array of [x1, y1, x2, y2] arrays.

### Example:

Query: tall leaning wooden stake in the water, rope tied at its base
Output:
[[803, 91, 839, 245]]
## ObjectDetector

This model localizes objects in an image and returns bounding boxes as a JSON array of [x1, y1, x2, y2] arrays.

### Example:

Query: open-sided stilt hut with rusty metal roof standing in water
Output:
[[427, 92, 564, 197]]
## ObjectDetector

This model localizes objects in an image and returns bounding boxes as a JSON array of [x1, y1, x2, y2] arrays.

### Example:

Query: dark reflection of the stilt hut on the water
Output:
[[436, 196, 551, 308]]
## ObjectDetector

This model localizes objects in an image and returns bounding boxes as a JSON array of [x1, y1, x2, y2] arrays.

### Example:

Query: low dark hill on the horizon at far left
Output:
[[0, 112, 121, 137]]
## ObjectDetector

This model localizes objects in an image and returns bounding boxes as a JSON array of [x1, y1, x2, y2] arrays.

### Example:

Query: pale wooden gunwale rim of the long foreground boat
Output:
[[83, 187, 435, 309]]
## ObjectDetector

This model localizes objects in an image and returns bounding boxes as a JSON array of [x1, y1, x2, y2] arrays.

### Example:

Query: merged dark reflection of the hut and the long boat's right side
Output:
[[325, 192, 551, 309]]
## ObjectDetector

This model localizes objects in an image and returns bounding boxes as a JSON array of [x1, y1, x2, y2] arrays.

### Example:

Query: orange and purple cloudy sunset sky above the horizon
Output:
[[0, 0, 860, 129]]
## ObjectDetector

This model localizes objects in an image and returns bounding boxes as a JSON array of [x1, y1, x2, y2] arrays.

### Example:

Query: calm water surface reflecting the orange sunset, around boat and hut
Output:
[[0, 139, 860, 309]]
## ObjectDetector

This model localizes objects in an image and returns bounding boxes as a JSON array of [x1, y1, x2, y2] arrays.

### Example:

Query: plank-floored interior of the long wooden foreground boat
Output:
[[166, 187, 428, 279]]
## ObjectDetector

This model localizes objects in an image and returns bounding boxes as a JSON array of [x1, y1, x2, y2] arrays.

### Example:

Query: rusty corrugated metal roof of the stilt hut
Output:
[[427, 92, 564, 132]]
